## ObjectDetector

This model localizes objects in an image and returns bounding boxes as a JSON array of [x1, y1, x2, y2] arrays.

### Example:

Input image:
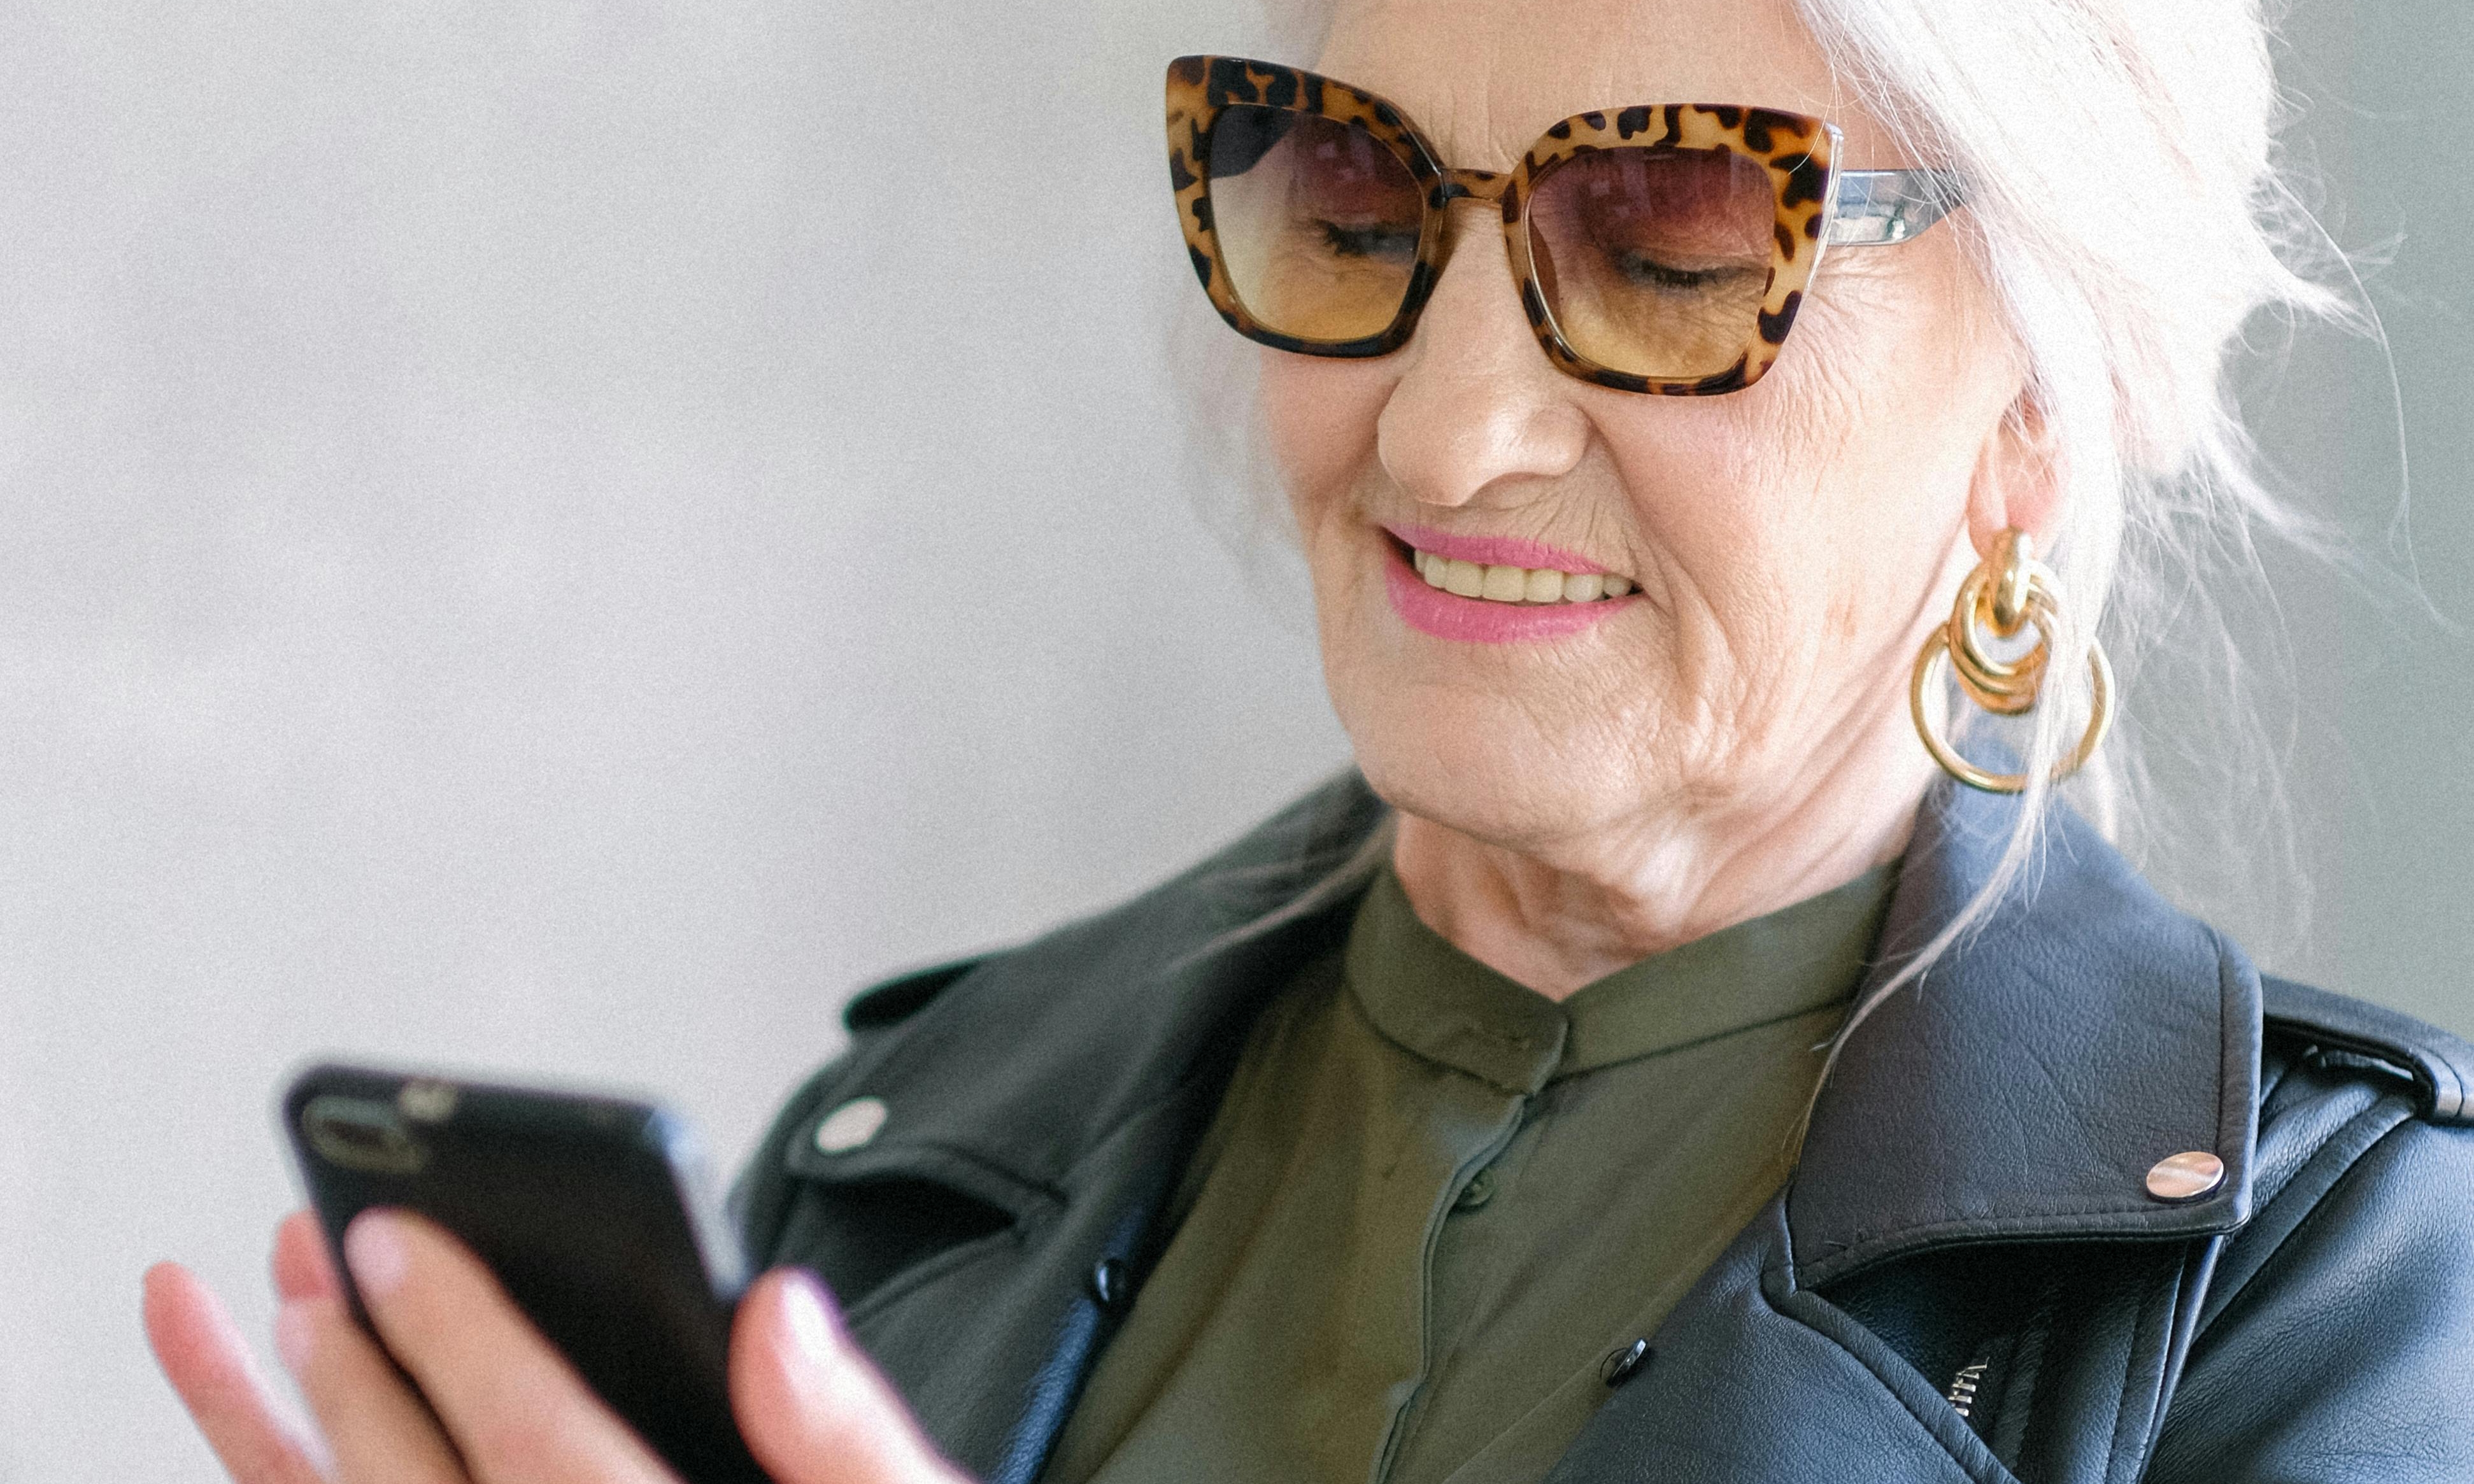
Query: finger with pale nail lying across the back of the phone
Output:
[[344, 1212, 676, 1484]]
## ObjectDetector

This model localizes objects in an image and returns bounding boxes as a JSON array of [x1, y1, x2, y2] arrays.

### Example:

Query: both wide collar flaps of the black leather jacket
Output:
[[789, 772, 2259, 1283]]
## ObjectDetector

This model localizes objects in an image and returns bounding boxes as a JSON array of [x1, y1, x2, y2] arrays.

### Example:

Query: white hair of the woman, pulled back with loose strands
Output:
[[1177, 0, 2375, 1009]]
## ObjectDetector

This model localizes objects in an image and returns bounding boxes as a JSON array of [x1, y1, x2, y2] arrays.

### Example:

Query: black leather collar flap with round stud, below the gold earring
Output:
[[1786, 784, 2259, 1286]]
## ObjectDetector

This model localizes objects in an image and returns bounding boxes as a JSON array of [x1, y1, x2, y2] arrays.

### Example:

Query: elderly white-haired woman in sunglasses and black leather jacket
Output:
[[151, 0, 2474, 1484]]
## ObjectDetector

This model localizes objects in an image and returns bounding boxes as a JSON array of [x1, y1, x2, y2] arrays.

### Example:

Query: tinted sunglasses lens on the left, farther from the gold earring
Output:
[[1205, 104, 1425, 344]]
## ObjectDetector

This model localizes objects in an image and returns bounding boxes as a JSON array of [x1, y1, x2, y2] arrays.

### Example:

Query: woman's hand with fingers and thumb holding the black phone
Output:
[[146, 1212, 962, 1484]]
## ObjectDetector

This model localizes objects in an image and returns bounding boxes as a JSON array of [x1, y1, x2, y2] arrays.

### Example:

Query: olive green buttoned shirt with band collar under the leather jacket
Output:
[[1044, 866, 1893, 1484]]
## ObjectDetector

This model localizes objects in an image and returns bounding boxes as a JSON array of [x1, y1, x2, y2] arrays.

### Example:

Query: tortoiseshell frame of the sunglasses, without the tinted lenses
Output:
[[1168, 57, 1959, 396]]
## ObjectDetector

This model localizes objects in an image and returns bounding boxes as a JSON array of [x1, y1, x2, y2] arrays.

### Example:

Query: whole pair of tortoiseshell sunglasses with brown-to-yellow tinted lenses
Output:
[[1168, 57, 1959, 396]]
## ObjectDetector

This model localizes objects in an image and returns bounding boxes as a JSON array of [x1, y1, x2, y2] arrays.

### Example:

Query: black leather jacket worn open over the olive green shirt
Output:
[[740, 774, 2474, 1484]]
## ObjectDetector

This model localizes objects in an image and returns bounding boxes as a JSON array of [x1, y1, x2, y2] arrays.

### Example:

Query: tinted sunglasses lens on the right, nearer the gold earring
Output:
[[1529, 146, 1776, 381]]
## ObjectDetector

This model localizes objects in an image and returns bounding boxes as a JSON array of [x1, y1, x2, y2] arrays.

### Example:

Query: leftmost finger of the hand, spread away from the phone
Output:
[[146, 1261, 322, 1484]]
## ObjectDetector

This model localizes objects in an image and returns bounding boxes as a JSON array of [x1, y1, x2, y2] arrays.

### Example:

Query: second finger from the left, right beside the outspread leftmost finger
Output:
[[274, 1294, 465, 1484]]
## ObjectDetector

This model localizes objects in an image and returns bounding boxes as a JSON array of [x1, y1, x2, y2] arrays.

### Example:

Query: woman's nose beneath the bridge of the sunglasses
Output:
[[1376, 203, 1588, 505]]
